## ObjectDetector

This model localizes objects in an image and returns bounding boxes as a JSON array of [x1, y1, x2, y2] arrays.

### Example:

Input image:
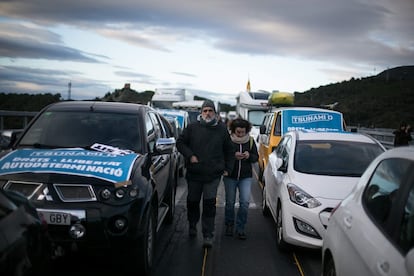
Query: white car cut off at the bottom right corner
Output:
[[322, 147, 414, 276]]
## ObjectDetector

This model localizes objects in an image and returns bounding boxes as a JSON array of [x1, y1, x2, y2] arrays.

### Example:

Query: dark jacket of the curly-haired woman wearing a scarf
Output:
[[229, 137, 259, 179]]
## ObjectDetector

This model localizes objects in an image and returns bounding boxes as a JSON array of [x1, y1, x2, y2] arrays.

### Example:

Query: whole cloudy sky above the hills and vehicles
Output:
[[0, 0, 414, 103]]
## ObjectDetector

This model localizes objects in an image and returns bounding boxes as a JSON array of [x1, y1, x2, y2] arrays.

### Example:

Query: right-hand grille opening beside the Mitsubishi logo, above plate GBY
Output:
[[53, 184, 97, 202]]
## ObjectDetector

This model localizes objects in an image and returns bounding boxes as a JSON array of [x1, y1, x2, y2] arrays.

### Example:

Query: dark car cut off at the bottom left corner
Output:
[[0, 189, 51, 276]]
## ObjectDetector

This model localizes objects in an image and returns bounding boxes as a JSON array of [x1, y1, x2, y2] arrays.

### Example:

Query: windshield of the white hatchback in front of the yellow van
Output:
[[294, 141, 383, 177]]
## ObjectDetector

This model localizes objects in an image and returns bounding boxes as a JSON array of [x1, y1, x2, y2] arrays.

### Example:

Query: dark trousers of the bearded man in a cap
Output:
[[187, 177, 221, 237]]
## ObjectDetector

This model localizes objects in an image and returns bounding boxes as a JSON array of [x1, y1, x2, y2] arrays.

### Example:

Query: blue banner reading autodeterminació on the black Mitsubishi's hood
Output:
[[0, 148, 138, 183]]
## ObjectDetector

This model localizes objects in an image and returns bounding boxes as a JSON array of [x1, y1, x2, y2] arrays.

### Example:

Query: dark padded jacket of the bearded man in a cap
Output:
[[177, 121, 235, 182]]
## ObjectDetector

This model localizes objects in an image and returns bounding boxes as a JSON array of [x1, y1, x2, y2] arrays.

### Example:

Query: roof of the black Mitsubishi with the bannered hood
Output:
[[45, 101, 154, 113]]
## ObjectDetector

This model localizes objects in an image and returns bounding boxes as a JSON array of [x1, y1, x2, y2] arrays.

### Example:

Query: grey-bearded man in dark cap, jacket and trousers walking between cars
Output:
[[177, 100, 235, 248]]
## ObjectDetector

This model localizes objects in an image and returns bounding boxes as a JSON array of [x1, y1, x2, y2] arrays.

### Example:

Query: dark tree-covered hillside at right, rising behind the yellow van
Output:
[[295, 66, 414, 128]]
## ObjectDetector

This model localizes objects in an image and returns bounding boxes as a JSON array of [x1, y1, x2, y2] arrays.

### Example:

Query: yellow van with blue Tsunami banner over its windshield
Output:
[[258, 107, 345, 180]]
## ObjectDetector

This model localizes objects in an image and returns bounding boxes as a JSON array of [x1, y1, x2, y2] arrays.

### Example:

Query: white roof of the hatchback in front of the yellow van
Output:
[[288, 131, 378, 144]]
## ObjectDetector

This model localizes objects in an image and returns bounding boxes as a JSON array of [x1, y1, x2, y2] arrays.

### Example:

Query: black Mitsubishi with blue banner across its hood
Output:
[[0, 101, 177, 274]]
